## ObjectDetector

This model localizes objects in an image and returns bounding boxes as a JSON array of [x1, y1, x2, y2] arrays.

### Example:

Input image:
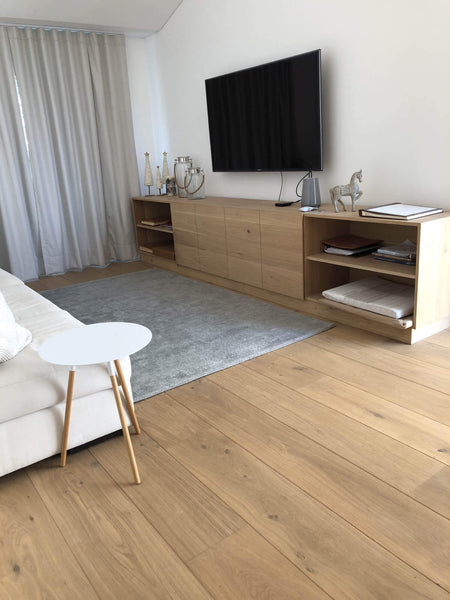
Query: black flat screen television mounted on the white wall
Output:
[[205, 50, 322, 171]]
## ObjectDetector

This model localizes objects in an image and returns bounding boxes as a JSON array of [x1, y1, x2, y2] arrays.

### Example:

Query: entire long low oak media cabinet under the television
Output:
[[132, 196, 450, 344]]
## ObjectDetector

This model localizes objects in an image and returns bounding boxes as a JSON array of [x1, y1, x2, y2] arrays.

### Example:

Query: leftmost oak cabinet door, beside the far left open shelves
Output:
[[170, 202, 199, 269]]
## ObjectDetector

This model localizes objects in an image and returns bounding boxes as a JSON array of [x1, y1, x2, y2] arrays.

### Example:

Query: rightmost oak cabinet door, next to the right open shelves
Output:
[[260, 211, 304, 300]]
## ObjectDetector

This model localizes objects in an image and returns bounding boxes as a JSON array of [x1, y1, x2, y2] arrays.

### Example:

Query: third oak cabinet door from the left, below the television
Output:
[[225, 208, 262, 287]]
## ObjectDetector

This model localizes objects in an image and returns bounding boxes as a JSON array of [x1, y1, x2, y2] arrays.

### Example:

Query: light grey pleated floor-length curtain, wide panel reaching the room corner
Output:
[[0, 27, 139, 279]]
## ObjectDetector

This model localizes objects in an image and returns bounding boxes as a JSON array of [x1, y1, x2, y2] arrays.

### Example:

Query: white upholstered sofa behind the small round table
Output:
[[0, 269, 131, 476]]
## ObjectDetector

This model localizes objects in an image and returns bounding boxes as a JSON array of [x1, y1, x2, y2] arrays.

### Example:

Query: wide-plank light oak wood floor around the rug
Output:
[[0, 263, 450, 600]]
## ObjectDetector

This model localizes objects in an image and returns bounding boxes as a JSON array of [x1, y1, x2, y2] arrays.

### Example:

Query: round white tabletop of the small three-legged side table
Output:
[[39, 322, 152, 366]]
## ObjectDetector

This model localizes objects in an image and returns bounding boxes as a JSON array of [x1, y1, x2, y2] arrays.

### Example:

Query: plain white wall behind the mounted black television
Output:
[[128, 0, 450, 209]]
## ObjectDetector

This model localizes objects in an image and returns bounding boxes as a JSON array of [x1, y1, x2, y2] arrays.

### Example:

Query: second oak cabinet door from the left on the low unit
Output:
[[195, 204, 228, 277]]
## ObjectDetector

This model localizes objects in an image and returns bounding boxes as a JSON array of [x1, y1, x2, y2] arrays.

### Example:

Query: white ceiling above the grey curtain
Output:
[[0, 0, 183, 36]]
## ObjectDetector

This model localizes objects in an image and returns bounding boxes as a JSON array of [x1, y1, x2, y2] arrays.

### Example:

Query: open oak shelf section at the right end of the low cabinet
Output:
[[303, 207, 450, 343]]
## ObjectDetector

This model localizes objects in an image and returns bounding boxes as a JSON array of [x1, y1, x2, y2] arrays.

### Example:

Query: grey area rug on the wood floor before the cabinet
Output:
[[42, 268, 333, 400]]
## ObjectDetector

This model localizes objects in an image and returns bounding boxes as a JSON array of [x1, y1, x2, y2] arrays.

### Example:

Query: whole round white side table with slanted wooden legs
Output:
[[39, 322, 152, 483]]
